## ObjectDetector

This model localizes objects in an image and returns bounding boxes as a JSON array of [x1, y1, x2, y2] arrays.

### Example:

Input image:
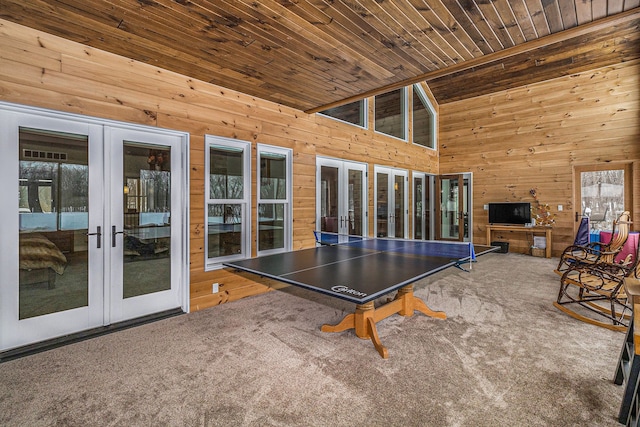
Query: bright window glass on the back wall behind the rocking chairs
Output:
[[580, 169, 625, 230]]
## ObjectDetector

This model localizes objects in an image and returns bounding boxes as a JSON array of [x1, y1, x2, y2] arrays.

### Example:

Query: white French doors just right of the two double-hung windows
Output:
[[316, 157, 367, 236]]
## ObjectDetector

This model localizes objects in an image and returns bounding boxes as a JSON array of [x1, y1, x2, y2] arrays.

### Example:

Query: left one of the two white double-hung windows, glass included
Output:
[[205, 135, 251, 267]]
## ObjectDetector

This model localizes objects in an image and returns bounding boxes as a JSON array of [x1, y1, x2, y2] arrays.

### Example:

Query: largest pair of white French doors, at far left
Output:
[[0, 105, 187, 351]]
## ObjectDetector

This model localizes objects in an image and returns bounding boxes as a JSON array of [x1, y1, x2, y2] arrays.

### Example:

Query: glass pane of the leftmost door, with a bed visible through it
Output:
[[18, 128, 89, 319]]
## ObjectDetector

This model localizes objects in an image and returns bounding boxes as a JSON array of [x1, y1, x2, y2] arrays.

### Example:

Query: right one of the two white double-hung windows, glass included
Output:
[[257, 144, 293, 255]]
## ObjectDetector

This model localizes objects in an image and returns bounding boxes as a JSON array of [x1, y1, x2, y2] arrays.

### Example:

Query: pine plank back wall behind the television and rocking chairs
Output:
[[439, 60, 640, 256]]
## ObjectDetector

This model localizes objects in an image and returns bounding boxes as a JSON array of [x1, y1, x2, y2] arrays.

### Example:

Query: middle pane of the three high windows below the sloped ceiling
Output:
[[375, 88, 407, 140]]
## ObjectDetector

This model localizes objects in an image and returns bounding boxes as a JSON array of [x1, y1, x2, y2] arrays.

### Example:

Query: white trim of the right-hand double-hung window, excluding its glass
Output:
[[256, 144, 293, 256]]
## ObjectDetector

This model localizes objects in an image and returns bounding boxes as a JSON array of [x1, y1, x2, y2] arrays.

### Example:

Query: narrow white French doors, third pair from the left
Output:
[[374, 166, 409, 238]]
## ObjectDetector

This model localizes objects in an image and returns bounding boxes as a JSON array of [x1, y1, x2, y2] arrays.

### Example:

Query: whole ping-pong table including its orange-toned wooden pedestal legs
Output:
[[223, 236, 498, 359]]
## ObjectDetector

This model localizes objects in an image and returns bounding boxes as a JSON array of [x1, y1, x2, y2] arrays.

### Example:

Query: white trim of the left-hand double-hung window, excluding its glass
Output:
[[204, 135, 251, 271]]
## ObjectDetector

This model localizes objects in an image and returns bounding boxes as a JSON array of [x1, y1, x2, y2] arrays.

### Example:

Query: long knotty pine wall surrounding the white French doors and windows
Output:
[[0, 20, 438, 310]]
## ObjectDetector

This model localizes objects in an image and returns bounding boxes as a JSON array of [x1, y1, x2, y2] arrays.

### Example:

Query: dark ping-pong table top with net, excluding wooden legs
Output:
[[223, 233, 498, 304]]
